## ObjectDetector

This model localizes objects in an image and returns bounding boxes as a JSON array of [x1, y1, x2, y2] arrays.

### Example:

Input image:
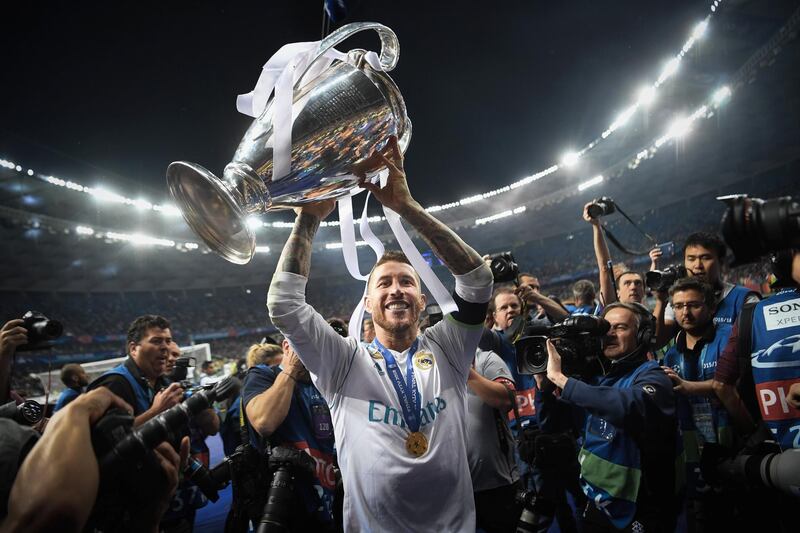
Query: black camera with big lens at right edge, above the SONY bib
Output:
[[717, 194, 800, 266]]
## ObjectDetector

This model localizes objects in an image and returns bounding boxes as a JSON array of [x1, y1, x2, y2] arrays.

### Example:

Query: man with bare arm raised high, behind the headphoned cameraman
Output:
[[583, 202, 644, 305]]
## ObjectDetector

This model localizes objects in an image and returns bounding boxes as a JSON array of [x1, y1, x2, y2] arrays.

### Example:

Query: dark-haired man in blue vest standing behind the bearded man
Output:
[[653, 233, 760, 349]]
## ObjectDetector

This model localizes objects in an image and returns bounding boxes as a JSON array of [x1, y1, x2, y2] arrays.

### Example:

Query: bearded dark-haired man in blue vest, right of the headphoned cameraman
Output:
[[663, 278, 735, 531]]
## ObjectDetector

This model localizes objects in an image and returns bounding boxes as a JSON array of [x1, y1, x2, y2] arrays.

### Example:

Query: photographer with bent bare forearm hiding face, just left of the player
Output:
[[242, 340, 336, 531]]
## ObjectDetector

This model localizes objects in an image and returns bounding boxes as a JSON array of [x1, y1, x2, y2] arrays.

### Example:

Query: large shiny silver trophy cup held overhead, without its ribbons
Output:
[[167, 23, 411, 264]]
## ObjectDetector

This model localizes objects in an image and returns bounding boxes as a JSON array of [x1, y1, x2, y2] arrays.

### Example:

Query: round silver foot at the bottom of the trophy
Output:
[[167, 161, 256, 265]]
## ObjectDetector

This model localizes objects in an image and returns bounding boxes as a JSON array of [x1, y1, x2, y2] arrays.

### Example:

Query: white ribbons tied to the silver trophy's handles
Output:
[[236, 36, 457, 339]]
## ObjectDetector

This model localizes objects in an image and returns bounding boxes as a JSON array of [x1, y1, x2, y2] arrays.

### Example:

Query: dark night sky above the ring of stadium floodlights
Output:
[[0, 0, 740, 205]]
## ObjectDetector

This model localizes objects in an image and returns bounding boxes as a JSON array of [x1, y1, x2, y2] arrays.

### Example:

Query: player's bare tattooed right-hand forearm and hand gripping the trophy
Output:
[[361, 137, 483, 274]]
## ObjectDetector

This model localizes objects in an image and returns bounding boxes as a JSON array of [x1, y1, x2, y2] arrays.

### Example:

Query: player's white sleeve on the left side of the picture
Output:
[[267, 272, 358, 396]]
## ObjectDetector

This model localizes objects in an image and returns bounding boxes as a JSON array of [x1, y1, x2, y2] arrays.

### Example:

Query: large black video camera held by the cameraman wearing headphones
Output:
[[514, 315, 611, 378]]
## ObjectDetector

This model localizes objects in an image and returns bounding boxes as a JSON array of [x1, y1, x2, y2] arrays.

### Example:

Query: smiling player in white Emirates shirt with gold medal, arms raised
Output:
[[268, 137, 492, 531]]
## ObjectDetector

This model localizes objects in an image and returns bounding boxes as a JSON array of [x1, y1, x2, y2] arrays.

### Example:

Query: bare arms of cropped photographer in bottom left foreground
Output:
[[0, 388, 189, 533]]
